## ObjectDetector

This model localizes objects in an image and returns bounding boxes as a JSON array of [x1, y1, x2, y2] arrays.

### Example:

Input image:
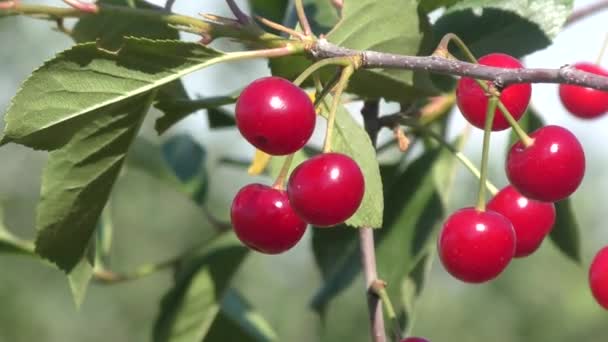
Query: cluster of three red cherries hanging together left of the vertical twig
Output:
[[230, 77, 365, 254]]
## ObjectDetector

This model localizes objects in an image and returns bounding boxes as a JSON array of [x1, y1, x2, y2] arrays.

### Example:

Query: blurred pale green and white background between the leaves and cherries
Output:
[[0, 1, 608, 342]]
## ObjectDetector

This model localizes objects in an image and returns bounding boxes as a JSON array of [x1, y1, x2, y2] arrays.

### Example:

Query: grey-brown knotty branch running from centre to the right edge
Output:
[[310, 39, 608, 91]]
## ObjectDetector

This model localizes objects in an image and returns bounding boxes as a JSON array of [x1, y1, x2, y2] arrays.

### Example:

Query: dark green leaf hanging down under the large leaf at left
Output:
[[36, 93, 154, 272]]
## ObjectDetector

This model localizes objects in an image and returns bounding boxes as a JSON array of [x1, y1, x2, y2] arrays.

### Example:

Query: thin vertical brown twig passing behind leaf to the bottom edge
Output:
[[359, 100, 386, 342]]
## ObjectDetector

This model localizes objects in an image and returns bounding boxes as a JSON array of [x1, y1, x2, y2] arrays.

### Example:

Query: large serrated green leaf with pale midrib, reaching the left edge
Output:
[[1, 38, 227, 150]]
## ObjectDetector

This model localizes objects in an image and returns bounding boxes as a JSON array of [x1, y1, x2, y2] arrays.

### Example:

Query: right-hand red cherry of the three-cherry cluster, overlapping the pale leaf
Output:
[[287, 153, 365, 227]]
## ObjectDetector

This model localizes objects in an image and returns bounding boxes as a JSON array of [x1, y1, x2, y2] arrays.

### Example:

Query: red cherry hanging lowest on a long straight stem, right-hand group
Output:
[[437, 208, 515, 283]]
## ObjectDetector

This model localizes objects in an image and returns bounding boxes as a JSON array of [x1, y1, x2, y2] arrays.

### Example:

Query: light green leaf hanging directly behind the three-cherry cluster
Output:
[[321, 100, 384, 228]]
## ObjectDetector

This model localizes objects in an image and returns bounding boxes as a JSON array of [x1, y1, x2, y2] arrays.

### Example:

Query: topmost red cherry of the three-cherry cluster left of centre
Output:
[[236, 77, 316, 155]]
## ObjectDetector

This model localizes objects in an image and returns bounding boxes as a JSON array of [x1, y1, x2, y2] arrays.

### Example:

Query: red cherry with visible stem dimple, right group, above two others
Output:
[[506, 126, 585, 202]]
